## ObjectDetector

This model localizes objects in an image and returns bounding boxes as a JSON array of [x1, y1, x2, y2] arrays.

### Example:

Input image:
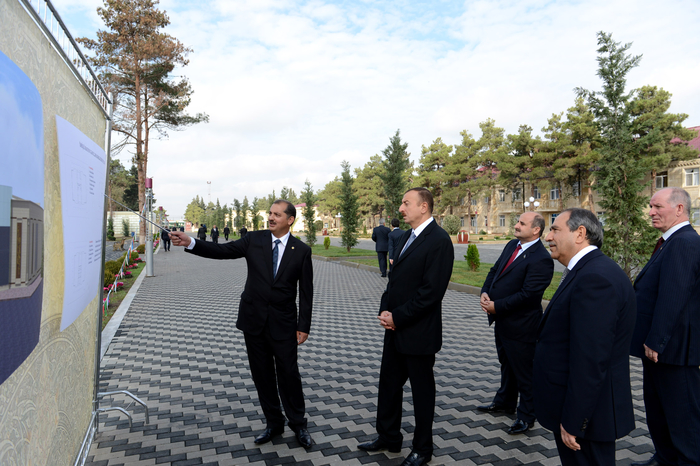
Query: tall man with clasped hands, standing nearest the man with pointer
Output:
[[358, 188, 454, 466]]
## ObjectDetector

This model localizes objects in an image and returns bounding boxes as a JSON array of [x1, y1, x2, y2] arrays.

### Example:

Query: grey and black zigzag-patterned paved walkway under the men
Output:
[[88, 242, 653, 466]]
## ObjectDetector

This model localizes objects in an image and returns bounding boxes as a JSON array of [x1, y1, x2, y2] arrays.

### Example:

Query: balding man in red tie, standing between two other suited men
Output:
[[479, 212, 554, 434]]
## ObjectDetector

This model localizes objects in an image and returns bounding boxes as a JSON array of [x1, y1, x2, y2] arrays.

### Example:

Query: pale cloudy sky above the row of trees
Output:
[[53, 0, 700, 217]]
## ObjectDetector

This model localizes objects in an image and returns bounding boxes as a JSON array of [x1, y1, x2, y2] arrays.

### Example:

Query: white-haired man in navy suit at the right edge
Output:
[[630, 188, 700, 466]]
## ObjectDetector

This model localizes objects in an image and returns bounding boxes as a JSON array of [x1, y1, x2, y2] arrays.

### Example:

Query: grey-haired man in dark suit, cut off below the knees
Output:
[[533, 209, 636, 466]]
